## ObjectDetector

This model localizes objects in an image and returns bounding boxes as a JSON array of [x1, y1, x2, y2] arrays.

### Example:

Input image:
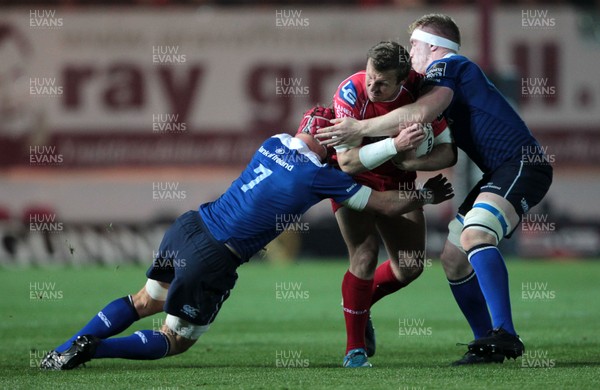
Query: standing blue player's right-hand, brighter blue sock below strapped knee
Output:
[[468, 244, 517, 335]]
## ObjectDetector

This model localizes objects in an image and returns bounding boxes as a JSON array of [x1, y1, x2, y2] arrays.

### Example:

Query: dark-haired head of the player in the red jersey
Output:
[[365, 41, 411, 102]]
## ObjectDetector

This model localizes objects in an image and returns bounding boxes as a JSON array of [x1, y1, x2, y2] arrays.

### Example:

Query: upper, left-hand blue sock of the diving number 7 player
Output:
[[56, 296, 140, 352]]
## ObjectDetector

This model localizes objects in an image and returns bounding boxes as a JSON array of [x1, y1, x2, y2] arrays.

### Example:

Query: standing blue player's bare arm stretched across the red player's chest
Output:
[[316, 86, 454, 146]]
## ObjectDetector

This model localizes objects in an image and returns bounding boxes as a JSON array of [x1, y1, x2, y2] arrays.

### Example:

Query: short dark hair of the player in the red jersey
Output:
[[367, 41, 411, 83]]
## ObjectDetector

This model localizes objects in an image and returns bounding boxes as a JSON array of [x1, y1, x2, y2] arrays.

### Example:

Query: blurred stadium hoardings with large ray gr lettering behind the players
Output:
[[0, 0, 600, 264]]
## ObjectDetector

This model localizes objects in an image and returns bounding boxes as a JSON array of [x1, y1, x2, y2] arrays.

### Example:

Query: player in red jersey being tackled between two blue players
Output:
[[333, 41, 456, 367]]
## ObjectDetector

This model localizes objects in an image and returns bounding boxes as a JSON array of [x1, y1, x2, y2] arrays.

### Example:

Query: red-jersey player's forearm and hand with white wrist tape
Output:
[[336, 125, 424, 175]]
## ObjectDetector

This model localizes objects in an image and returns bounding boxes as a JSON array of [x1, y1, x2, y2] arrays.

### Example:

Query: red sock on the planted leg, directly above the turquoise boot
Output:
[[342, 271, 373, 353]]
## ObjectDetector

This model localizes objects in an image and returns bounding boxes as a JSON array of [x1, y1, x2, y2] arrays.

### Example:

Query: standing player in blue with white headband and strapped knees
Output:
[[317, 14, 552, 365]]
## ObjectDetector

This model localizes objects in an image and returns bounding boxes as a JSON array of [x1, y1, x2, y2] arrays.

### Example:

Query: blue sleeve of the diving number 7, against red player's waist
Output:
[[312, 164, 361, 203]]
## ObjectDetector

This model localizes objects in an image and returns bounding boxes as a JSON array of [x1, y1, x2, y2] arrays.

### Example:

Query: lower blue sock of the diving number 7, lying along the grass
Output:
[[94, 330, 169, 360]]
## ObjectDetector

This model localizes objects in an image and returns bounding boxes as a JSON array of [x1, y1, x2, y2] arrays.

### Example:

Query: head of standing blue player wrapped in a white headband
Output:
[[408, 14, 460, 73]]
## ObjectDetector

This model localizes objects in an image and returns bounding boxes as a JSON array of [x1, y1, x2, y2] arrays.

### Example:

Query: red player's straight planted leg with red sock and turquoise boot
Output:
[[335, 207, 379, 367]]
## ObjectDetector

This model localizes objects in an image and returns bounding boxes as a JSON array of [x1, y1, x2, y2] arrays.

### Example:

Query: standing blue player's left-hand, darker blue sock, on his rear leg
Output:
[[448, 271, 492, 339]]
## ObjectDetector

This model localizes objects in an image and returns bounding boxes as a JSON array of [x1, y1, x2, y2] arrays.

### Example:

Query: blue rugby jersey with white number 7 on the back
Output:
[[199, 134, 361, 261]]
